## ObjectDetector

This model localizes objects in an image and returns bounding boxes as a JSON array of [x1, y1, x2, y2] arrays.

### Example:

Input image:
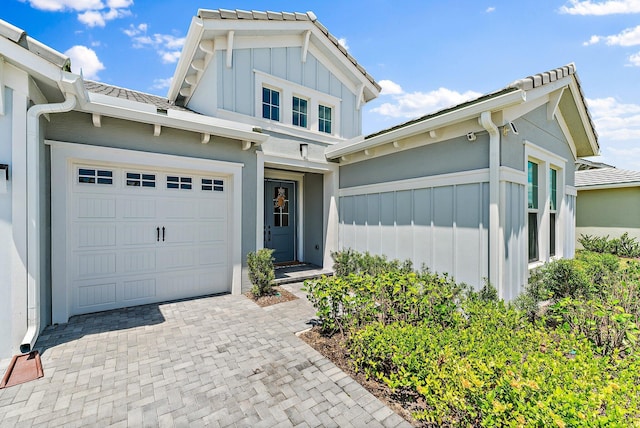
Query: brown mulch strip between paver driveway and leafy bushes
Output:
[[299, 327, 427, 427]]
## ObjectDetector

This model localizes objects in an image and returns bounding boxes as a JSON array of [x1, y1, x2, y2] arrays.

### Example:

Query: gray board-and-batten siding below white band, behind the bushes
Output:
[[339, 183, 489, 287]]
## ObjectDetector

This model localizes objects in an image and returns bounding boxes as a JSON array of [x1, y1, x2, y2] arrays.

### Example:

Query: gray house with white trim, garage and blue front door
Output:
[[0, 10, 598, 358]]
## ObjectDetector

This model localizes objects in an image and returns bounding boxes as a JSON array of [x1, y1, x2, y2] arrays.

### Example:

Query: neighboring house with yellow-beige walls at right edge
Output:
[[576, 165, 640, 240]]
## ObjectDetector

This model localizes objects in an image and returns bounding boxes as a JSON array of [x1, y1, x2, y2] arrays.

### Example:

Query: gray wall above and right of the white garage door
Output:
[[44, 112, 257, 272]]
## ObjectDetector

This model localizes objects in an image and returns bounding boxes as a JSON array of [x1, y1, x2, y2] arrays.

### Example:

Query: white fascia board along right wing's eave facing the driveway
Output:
[[325, 90, 527, 159]]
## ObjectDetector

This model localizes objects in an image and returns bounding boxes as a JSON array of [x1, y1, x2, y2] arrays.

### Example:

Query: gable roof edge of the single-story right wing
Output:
[[326, 63, 599, 159]]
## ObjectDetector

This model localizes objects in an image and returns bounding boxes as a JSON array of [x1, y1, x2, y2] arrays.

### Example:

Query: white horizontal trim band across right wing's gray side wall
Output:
[[338, 168, 489, 197]]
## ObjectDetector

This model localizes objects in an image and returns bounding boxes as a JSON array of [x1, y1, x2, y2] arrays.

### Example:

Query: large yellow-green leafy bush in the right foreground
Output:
[[349, 300, 640, 427]]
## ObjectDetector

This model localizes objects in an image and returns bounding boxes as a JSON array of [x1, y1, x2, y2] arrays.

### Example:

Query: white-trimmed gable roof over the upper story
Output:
[[167, 9, 381, 104]]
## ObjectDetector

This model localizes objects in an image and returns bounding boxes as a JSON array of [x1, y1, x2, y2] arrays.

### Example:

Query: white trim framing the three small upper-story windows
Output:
[[253, 69, 342, 137]]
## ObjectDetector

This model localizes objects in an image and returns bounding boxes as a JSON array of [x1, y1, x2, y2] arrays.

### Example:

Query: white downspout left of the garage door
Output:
[[20, 92, 77, 353]]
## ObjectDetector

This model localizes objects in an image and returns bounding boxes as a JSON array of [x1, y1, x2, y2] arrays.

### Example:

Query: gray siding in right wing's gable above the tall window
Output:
[[500, 104, 575, 186]]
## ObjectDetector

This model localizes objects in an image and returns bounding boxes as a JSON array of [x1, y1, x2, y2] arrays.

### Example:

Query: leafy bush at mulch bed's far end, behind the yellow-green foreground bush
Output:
[[304, 269, 463, 333]]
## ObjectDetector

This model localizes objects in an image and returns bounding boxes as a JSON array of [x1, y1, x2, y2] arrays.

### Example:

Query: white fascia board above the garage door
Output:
[[82, 98, 269, 144]]
